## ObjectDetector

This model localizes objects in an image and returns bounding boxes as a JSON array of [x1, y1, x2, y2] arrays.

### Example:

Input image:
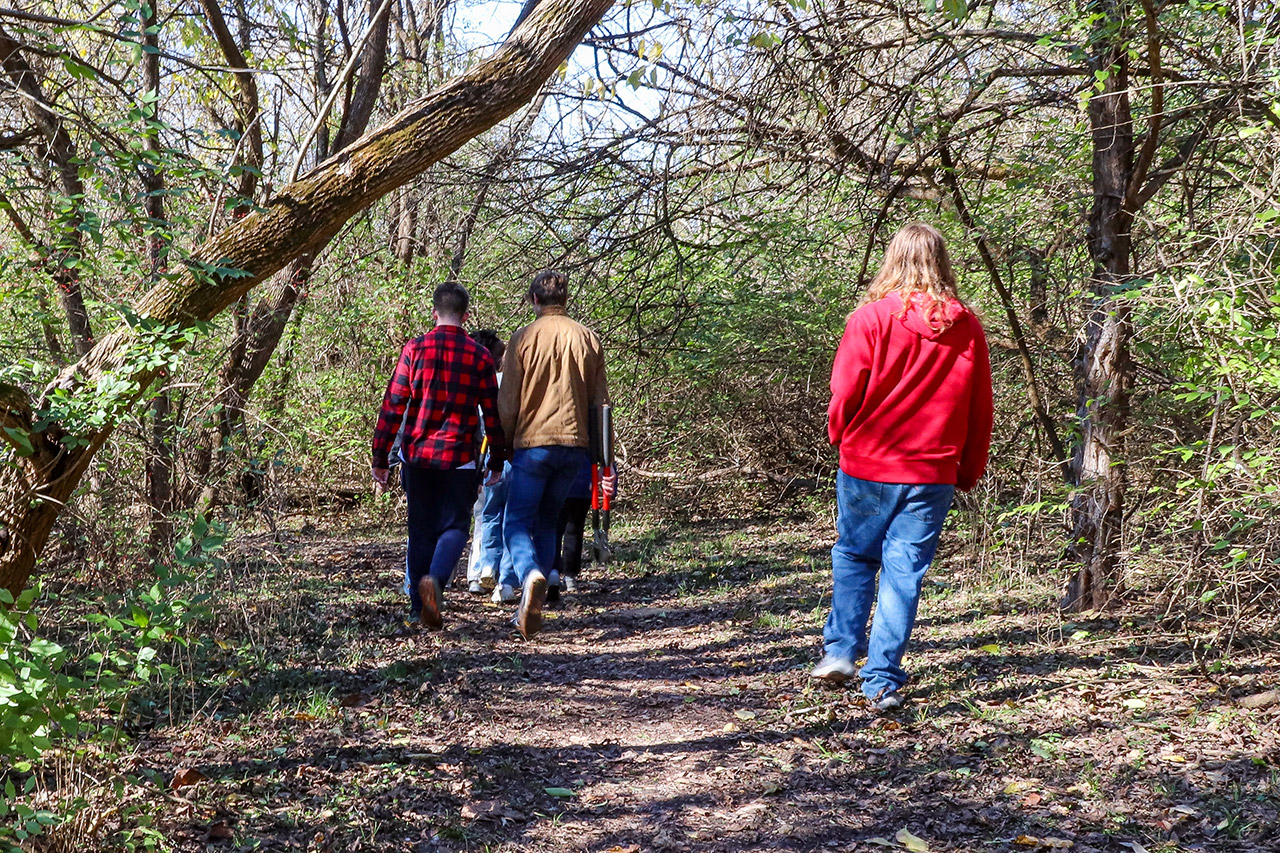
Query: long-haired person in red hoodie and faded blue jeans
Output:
[[813, 223, 992, 711]]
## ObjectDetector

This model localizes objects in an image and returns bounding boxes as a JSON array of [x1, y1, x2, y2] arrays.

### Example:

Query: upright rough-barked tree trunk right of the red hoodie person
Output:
[[1062, 0, 1136, 610]]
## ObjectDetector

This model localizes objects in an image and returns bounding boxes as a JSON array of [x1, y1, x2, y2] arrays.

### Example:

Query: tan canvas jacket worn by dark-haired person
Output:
[[498, 305, 609, 450]]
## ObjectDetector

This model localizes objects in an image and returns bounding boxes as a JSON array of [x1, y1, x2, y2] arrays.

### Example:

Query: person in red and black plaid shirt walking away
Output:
[[372, 282, 508, 630]]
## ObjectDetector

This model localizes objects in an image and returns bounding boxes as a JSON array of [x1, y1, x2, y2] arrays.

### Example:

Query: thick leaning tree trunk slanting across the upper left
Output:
[[0, 0, 612, 592]]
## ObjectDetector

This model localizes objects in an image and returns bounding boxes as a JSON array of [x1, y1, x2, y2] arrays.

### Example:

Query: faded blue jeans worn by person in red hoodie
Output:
[[822, 471, 955, 699]]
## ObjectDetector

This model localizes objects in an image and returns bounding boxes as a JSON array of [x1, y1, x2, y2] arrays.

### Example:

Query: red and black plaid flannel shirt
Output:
[[374, 325, 507, 471]]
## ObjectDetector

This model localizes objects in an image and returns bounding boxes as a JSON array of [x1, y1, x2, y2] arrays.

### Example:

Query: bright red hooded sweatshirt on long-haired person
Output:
[[827, 293, 992, 492]]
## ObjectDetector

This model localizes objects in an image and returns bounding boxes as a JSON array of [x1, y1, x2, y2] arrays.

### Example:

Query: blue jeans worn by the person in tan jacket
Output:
[[502, 446, 590, 587]]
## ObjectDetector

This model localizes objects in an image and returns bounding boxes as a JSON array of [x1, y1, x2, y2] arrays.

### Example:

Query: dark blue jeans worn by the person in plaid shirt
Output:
[[401, 465, 480, 613]]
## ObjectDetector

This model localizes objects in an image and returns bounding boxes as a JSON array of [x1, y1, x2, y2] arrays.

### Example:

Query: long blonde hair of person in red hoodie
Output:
[[860, 222, 964, 330]]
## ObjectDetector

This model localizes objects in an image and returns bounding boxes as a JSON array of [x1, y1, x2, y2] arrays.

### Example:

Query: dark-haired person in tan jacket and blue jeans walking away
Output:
[[498, 270, 613, 639]]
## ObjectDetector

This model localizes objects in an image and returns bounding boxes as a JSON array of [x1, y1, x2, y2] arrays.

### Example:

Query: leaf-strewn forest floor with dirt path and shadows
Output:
[[57, 519, 1280, 853]]
